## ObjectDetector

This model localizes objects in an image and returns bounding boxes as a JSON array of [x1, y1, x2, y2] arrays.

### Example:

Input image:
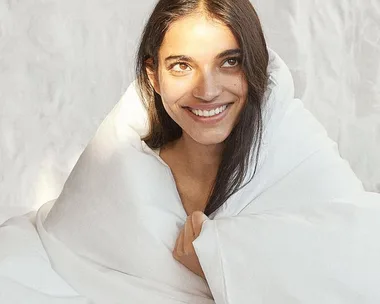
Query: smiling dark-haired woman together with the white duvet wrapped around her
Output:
[[0, 0, 380, 304]]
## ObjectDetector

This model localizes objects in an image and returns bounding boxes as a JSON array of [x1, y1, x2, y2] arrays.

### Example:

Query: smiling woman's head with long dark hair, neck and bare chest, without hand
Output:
[[136, 0, 268, 215]]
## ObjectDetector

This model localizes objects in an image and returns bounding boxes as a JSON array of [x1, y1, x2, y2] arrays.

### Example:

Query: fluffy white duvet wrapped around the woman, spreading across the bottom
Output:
[[0, 51, 380, 304]]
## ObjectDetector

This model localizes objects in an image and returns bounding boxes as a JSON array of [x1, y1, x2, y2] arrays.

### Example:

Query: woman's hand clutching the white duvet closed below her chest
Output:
[[173, 211, 208, 279]]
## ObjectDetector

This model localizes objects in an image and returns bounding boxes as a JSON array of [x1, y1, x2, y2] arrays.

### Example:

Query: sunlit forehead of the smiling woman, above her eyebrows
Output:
[[160, 15, 239, 59]]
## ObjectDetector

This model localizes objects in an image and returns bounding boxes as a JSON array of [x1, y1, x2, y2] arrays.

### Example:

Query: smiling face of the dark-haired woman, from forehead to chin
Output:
[[150, 15, 247, 145]]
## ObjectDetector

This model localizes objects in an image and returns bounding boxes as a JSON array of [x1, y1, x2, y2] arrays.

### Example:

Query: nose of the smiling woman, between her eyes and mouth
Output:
[[193, 73, 222, 101]]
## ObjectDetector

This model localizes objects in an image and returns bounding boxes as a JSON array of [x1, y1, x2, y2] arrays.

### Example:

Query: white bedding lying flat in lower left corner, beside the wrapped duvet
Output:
[[0, 212, 91, 304]]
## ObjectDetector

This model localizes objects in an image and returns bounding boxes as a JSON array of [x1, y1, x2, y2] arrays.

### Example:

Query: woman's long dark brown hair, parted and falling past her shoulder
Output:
[[136, 0, 269, 216]]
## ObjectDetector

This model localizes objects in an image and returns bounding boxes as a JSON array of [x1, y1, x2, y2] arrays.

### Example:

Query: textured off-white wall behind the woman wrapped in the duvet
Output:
[[0, 0, 380, 221]]
